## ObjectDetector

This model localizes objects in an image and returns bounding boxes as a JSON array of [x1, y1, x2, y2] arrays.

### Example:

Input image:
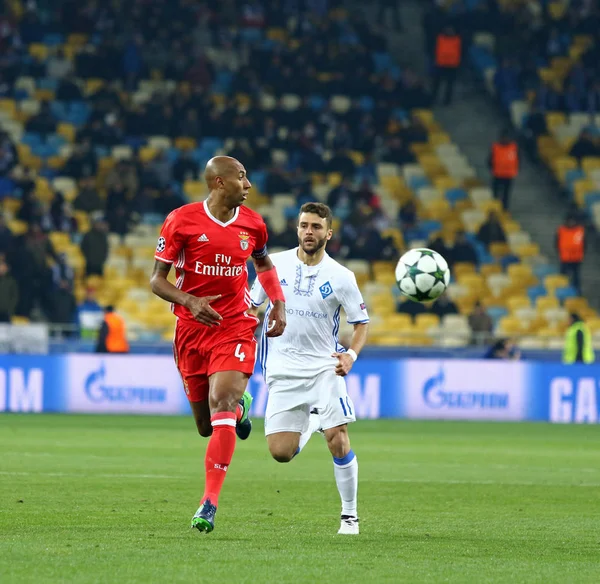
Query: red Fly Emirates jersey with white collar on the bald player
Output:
[[154, 201, 267, 322]]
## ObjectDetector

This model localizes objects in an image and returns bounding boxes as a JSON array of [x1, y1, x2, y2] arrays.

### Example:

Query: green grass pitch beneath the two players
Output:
[[0, 415, 600, 584]]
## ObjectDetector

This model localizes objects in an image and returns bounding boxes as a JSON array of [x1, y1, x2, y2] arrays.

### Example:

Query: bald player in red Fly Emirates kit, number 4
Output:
[[150, 156, 286, 532]]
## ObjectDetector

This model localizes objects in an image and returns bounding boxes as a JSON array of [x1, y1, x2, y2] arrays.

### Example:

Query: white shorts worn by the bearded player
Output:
[[265, 368, 356, 436]]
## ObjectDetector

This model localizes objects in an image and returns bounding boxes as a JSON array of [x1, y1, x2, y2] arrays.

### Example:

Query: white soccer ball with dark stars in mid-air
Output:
[[396, 248, 450, 302]]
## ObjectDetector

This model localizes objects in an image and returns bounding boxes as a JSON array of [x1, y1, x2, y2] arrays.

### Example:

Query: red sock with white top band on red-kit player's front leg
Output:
[[200, 412, 237, 505]]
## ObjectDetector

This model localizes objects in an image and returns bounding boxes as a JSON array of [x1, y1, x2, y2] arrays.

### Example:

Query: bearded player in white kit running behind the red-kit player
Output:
[[250, 203, 369, 535]]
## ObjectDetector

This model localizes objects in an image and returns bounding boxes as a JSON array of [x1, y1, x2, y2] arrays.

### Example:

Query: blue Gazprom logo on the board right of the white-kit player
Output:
[[422, 367, 510, 410]]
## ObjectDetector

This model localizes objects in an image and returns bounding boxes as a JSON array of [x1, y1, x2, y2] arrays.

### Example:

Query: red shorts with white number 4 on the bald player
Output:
[[173, 316, 258, 402]]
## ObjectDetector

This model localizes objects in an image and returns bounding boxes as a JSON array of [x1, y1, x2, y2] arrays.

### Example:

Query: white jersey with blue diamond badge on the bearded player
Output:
[[250, 248, 369, 383]]
